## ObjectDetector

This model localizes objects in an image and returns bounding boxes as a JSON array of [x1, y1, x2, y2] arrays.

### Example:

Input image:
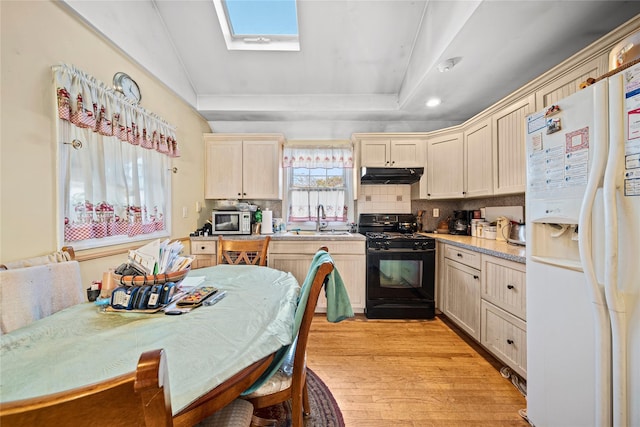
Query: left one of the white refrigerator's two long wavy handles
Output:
[[578, 84, 611, 426]]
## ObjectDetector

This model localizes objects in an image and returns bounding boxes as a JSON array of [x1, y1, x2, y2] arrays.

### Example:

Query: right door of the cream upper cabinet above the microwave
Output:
[[242, 140, 282, 199]]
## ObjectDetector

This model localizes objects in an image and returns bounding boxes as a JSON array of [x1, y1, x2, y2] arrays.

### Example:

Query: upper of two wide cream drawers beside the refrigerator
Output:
[[482, 255, 527, 320]]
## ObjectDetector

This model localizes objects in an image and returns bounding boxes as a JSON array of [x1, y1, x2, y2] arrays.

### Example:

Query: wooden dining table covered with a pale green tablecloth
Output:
[[0, 265, 300, 425]]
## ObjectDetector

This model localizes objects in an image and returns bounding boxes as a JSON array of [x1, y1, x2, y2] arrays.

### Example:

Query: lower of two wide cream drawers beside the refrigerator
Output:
[[480, 300, 527, 379]]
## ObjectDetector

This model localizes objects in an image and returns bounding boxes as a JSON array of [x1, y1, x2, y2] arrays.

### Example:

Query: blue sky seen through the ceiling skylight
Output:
[[225, 0, 298, 36]]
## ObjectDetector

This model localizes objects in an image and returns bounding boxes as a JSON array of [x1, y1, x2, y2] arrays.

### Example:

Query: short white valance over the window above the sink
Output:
[[283, 146, 353, 168]]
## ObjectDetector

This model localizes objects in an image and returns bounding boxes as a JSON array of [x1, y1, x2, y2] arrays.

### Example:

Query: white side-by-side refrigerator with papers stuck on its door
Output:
[[525, 65, 640, 427]]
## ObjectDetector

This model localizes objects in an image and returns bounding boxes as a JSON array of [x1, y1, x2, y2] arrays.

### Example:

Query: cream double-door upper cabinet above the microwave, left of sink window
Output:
[[204, 134, 284, 200]]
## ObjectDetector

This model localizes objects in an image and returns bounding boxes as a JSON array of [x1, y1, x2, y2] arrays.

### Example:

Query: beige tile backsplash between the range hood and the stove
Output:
[[357, 184, 411, 214]]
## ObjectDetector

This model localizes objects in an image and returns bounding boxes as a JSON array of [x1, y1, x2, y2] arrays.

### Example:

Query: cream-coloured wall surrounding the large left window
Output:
[[0, 0, 209, 283]]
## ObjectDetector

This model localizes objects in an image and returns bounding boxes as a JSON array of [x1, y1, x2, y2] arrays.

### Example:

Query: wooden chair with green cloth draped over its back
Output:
[[244, 247, 334, 427]]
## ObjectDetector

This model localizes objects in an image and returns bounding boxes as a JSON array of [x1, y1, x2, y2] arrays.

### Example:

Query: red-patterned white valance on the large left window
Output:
[[53, 64, 180, 157]]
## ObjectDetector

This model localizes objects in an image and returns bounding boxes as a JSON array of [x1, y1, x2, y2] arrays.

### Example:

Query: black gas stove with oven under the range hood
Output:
[[358, 214, 436, 319]]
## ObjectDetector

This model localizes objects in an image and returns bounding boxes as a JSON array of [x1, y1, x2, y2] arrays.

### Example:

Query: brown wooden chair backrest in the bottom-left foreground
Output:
[[0, 350, 173, 427]]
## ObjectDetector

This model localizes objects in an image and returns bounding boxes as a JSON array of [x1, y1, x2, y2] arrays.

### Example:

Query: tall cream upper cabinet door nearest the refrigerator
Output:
[[492, 95, 536, 195]]
